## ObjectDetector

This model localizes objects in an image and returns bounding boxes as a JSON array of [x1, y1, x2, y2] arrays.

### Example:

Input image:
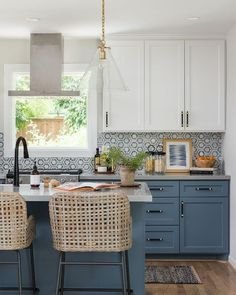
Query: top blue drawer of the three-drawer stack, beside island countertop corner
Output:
[[147, 181, 179, 198]]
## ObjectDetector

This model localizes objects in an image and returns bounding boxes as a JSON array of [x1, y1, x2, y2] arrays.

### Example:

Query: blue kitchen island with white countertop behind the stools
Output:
[[0, 183, 152, 295]]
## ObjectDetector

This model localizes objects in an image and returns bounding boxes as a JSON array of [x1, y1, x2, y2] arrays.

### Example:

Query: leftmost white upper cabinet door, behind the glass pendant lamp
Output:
[[103, 41, 144, 132]]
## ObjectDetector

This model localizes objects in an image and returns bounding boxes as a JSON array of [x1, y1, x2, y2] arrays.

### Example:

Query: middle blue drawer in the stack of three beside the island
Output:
[[145, 198, 179, 225]]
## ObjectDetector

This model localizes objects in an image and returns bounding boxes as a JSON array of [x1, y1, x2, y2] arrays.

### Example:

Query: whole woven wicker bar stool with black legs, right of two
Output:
[[49, 192, 132, 295]]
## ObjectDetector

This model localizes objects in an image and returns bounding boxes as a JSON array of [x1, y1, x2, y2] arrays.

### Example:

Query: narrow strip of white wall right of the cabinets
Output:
[[224, 25, 236, 267]]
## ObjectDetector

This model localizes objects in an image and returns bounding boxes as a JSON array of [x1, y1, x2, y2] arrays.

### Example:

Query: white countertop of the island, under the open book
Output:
[[0, 183, 152, 203]]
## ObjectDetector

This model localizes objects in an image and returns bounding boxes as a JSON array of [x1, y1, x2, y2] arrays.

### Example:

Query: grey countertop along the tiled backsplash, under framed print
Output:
[[80, 173, 230, 181]]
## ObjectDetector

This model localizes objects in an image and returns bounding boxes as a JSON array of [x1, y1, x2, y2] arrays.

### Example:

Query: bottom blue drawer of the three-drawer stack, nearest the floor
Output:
[[145, 226, 179, 254]]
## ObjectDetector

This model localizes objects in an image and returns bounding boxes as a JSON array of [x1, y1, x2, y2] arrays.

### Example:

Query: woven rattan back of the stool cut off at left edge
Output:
[[0, 193, 28, 250]]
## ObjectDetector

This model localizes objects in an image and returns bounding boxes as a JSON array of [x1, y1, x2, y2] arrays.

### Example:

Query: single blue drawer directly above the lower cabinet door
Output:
[[180, 180, 229, 197]]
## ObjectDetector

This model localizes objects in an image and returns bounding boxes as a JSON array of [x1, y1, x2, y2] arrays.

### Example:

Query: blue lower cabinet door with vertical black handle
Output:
[[180, 197, 229, 254]]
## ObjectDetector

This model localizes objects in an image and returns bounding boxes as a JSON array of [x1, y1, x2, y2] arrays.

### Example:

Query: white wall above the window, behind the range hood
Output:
[[0, 39, 97, 132]]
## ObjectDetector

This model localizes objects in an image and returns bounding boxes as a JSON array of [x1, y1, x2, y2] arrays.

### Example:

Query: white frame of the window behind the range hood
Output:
[[3, 64, 97, 157]]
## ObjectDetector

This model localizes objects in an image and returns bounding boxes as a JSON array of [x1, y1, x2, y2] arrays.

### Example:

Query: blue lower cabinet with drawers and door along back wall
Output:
[[145, 180, 229, 255]]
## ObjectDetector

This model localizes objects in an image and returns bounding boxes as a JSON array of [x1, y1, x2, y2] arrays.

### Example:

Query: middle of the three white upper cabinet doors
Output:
[[145, 40, 184, 131]]
